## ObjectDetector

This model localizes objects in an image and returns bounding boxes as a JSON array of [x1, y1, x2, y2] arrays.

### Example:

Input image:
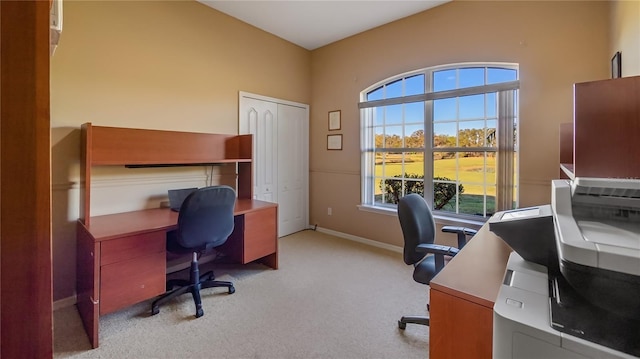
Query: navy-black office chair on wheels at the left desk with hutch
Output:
[[151, 186, 236, 318]]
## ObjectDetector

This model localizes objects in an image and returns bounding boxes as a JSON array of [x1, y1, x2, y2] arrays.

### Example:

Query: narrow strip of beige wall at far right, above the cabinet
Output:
[[609, 0, 640, 77]]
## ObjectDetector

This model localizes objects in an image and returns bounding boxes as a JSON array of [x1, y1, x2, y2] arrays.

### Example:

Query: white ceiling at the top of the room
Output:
[[197, 0, 450, 50]]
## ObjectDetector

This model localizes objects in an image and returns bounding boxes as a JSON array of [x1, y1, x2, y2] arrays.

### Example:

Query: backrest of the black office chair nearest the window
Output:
[[398, 193, 436, 264]]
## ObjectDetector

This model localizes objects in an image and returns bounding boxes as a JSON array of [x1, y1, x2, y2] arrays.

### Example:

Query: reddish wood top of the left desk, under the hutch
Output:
[[85, 199, 277, 241]]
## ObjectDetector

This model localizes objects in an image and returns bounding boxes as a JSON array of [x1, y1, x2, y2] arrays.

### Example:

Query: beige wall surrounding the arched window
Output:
[[310, 1, 608, 250]]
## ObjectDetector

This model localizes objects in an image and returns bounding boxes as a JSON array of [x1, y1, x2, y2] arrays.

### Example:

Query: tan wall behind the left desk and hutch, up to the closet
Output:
[[51, 0, 311, 300]]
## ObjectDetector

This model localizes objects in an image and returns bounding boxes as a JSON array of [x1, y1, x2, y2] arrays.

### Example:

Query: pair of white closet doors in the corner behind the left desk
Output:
[[238, 92, 309, 237]]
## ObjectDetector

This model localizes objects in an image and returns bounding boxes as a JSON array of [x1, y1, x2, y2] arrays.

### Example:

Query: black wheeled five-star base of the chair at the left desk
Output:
[[151, 256, 236, 318]]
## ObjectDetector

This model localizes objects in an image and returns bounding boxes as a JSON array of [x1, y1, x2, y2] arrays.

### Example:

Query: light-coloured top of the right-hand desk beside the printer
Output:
[[430, 223, 511, 309]]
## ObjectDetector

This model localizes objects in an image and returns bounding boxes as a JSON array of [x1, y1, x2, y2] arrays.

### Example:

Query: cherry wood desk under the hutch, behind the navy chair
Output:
[[76, 199, 278, 348]]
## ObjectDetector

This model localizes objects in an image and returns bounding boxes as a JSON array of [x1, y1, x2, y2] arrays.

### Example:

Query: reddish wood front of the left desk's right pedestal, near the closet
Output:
[[243, 207, 278, 263]]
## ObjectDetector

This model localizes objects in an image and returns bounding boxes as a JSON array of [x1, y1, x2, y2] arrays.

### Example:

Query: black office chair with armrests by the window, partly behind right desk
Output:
[[398, 193, 477, 329]]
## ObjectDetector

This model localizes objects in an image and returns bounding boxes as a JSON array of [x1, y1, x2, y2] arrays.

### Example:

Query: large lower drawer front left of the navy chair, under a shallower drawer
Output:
[[100, 252, 166, 315]]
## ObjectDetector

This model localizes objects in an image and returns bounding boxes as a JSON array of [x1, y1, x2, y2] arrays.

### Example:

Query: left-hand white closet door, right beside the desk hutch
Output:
[[239, 98, 278, 203]]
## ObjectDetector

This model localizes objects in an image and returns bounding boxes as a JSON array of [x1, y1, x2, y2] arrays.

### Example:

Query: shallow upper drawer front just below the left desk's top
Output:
[[100, 231, 166, 266]]
